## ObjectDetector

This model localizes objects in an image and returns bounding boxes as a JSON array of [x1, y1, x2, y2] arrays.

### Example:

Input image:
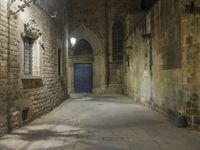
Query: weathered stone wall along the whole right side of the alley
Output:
[[124, 0, 200, 124]]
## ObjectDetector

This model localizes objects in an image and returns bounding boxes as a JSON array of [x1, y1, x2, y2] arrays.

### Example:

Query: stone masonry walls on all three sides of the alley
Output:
[[0, 0, 200, 135]]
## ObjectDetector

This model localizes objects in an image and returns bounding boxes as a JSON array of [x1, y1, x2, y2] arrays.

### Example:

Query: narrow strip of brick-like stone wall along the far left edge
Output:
[[0, 1, 9, 134]]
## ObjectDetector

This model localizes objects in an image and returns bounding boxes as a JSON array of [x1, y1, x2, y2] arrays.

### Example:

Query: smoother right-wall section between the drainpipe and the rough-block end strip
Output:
[[150, 0, 184, 112]]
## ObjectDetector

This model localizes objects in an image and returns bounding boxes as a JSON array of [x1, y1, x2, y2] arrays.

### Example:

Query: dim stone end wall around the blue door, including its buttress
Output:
[[67, 0, 140, 93]]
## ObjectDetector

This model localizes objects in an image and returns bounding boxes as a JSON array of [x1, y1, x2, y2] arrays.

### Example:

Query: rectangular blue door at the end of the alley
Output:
[[74, 64, 93, 93]]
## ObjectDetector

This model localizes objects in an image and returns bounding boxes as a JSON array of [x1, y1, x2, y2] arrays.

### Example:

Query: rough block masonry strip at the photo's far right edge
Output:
[[181, 8, 200, 125]]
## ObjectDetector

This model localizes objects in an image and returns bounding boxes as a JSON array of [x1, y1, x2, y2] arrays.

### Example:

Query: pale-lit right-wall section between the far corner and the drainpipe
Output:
[[124, 14, 150, 103]]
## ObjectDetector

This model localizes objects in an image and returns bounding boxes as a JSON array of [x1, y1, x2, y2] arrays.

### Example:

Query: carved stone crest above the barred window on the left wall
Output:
[[24, 17, 42, 36]]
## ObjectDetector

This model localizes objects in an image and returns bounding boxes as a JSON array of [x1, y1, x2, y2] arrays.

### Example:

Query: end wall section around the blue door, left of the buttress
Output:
[[67, 0, 106, 93]]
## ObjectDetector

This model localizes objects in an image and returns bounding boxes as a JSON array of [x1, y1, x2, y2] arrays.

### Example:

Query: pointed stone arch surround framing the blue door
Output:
[[68, 26, 106, 93]]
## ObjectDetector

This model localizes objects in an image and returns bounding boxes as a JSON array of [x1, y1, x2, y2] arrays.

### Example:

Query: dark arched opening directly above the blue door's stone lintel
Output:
[[74, 39, 93, 56]]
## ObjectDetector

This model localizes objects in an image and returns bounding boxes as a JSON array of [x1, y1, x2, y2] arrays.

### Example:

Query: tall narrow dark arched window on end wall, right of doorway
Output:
[[113, 21, 124, 63]]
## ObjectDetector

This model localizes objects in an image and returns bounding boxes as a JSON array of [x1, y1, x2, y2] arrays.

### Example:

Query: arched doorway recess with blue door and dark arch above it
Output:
[[73, 39, 93, 93]]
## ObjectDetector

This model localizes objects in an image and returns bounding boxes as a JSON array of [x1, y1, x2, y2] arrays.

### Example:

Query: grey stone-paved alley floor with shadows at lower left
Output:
[[0, 94, 200, 150]]
